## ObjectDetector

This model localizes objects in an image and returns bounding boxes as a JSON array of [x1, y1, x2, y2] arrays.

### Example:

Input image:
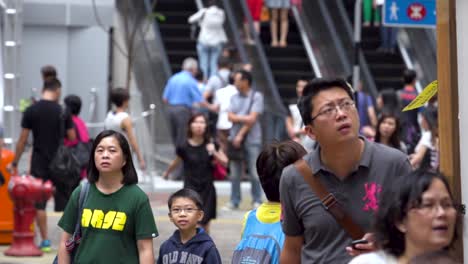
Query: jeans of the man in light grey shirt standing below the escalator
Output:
[[229, 144, 262, 207]]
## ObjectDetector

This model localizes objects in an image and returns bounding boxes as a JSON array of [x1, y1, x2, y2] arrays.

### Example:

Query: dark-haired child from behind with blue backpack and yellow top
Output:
[[232, 140, 307, 264]]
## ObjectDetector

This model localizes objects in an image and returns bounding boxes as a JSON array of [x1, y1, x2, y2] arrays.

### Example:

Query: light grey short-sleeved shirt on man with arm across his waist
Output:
[[228, 89, 263, 144]]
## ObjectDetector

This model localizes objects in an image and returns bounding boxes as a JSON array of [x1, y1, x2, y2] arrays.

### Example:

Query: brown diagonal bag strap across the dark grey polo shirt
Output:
[[294, 159, 364, 240]]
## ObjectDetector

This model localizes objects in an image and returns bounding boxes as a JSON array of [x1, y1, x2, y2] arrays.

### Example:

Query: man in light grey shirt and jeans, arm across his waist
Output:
[[227, 70, 263, 209]]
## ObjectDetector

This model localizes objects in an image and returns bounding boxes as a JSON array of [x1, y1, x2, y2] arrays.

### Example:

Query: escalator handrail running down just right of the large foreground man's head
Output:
[[336, 0, 379, 98]]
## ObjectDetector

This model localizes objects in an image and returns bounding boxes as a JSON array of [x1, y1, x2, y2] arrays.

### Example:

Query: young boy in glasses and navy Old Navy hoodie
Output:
[[157, 189, 222, 264]]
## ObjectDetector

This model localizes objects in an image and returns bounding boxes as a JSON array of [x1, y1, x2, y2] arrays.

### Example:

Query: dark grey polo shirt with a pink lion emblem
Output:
[[280, 138, 412, 263]]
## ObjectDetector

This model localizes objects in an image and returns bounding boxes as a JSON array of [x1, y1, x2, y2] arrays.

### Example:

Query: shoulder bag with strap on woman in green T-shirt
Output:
[[52, 181, 89, 264]]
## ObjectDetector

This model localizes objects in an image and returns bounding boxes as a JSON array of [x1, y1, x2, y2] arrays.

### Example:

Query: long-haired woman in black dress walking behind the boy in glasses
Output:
[[163, 114, 228, 232]]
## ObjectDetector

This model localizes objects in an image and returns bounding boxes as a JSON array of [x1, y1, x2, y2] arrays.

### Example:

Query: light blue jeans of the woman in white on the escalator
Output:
[[197, 43, 223, 79]]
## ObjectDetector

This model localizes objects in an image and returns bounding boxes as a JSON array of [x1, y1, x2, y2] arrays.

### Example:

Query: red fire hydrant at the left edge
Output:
[[5, 175, 54, 256]]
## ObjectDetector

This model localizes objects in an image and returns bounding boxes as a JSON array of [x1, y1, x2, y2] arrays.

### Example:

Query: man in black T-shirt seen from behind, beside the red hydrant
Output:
[[9, 79, 76, 252]]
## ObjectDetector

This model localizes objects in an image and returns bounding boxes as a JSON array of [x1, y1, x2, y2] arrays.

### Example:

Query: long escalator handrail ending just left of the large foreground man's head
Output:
[[240, 1, 287, 115]]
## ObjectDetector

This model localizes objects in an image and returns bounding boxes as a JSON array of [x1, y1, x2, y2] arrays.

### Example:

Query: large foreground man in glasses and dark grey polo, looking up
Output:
[[280, 79, 411, 263]]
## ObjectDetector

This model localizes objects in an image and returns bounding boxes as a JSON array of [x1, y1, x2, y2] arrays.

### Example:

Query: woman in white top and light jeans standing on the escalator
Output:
[[188, 0, 227, 79]]
